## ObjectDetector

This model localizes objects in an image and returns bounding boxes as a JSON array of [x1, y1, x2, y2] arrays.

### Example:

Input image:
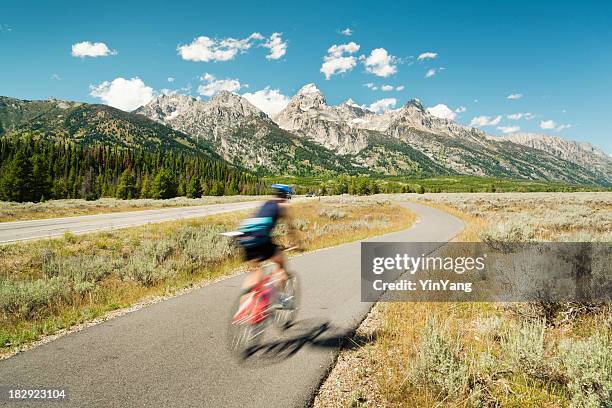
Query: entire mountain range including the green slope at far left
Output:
[[0, 84, 612, 186]]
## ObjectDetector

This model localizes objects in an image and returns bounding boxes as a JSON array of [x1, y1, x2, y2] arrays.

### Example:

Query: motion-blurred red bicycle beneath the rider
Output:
[[228, 247, 299, 357]]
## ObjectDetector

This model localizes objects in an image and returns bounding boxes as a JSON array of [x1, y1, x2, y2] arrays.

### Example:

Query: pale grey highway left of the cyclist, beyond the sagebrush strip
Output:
[[0, 201, 261, 244]]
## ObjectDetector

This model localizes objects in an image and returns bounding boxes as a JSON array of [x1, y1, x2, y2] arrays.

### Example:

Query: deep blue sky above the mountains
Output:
[[0, 0, 612, 153]]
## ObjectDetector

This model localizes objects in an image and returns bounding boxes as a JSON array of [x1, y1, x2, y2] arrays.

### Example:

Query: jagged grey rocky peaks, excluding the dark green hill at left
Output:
[[135, 84, 612, 185]]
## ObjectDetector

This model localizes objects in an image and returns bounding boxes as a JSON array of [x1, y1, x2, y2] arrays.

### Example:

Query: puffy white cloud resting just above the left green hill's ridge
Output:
[[89, 77, 155, 111]]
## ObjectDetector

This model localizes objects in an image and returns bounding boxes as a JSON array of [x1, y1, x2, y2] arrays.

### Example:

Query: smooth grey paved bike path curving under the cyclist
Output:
[[0, 203, 464, 407]]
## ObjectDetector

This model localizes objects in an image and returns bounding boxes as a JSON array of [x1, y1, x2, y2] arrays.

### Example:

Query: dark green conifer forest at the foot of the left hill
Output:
[[0, 138, 266, 202]]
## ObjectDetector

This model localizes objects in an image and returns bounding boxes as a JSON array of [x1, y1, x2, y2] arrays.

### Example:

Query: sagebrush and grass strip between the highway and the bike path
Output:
[[0, 197, 414, 355]]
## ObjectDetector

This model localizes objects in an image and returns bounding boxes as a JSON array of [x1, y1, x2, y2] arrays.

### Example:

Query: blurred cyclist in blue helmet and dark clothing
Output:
[[237, 184, 298, 314]]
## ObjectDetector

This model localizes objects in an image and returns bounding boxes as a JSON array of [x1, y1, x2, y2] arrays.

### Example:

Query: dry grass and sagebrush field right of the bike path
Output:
[[315, 193, 612, 407]]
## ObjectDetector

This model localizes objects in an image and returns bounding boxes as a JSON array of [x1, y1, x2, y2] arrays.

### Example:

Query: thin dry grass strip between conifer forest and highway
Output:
[[0, 196, 265, 222]]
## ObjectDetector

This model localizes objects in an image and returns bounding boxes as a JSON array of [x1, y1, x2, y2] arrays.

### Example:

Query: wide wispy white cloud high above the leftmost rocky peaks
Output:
[[176, 33, 262, 62]]
